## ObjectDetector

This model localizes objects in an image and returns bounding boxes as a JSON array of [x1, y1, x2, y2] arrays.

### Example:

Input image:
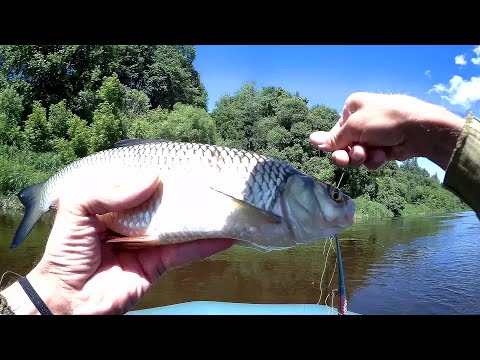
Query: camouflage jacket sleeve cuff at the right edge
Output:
[[443, 115, 480, 218]]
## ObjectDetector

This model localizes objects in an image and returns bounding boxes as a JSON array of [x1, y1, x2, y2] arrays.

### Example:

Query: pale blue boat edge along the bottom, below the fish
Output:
[[125, 301, 360, 315]]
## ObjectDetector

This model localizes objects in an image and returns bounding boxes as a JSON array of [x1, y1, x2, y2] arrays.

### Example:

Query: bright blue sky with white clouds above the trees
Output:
[[194, 45, 480, 180]]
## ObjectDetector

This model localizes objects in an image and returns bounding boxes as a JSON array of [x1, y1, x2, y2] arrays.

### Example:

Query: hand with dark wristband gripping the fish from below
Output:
[[2, 175, 233, 314]]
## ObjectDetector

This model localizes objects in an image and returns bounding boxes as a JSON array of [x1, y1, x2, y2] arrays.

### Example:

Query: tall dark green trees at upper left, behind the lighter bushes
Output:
[[0, 45, 207, 123]]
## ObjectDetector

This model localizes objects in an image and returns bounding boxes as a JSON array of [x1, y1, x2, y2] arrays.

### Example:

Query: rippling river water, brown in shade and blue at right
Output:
[[0, 211, 480, 314]]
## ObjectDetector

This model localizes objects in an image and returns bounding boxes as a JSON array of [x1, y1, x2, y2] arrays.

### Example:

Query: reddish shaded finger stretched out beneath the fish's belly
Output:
[[140, 239, 235, 281]]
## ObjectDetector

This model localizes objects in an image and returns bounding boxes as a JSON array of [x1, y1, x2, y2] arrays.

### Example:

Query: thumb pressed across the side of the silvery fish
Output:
[[59, 171, 159, 216]]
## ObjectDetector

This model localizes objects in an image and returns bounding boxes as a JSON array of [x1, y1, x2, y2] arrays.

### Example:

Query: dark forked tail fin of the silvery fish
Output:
[[10, 183, 45, 249]]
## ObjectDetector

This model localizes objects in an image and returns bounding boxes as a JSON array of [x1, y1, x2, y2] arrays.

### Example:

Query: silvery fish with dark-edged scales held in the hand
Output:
[[10, 139, 355, 252]]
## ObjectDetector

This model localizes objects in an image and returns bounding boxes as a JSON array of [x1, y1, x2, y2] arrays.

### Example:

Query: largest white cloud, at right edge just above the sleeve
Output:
[[429, 75, 480, 109]]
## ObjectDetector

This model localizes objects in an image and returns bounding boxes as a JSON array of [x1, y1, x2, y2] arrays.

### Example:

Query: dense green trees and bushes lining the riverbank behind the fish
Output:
[[0, 45, 468, 217]]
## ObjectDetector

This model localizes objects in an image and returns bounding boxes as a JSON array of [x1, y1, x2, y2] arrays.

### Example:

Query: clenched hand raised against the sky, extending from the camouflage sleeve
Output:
[[310, 93, 465, 170]]
